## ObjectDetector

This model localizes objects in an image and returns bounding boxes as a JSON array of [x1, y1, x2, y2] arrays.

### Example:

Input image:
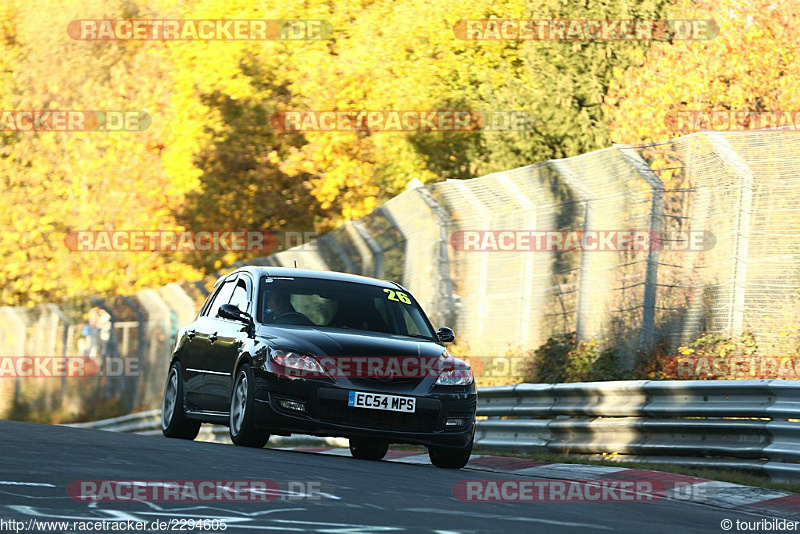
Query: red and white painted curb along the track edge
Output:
[[282, 447, 800, 521]]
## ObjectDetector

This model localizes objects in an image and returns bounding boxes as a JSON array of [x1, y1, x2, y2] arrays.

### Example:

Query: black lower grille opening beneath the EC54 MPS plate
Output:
[[320, 401, 439, 432]]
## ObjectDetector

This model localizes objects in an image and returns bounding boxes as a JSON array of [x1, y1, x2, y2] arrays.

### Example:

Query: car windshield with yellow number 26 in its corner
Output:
[[258, 277, 436, 340]]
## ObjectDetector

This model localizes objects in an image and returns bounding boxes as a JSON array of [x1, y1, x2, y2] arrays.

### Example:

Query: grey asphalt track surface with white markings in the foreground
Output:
[[0, 421, 784, 533]]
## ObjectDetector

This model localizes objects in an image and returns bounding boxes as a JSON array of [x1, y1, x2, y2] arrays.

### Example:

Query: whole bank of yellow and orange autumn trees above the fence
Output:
[[0, 0, 800, 304]]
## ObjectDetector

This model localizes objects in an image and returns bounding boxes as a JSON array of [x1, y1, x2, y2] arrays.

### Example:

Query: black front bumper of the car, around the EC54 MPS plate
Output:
[[254, 372, 477, 448]]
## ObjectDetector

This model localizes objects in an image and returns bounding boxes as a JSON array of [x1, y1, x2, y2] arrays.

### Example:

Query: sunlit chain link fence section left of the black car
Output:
[[0, 284, 207, 422]]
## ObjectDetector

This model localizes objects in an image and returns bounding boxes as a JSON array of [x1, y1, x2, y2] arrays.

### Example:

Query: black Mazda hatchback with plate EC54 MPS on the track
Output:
[[161, 267, 477, 468]]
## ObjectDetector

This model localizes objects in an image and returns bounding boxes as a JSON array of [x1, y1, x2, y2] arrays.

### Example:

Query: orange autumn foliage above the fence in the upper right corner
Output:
[[606, 0, 800, 163]]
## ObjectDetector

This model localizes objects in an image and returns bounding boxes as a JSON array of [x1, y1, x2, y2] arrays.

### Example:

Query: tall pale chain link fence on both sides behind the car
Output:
[[0, 131, 800, 422]]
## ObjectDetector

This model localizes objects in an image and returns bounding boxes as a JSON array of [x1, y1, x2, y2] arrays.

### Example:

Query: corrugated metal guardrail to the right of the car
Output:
[[475, 380, 800, 482]]
